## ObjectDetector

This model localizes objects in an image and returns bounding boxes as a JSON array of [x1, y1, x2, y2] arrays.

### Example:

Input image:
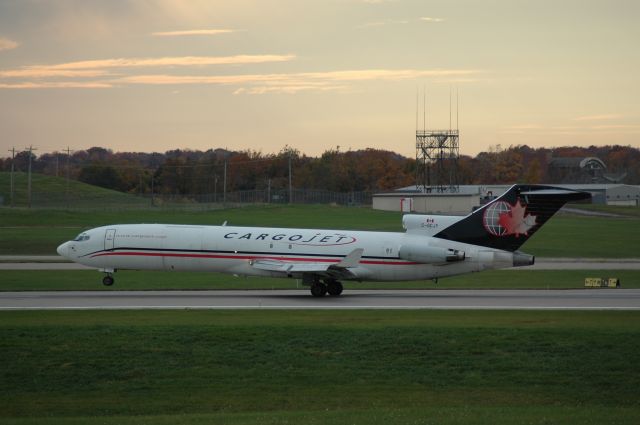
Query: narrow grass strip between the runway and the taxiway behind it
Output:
[[0, 270, 640, 291]]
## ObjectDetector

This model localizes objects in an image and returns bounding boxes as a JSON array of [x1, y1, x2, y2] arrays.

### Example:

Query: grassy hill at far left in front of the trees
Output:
[[0, 171, 149, 208]]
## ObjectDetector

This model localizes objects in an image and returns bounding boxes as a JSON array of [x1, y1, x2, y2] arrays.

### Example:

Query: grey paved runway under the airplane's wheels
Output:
[[0, 289, 640, 310]]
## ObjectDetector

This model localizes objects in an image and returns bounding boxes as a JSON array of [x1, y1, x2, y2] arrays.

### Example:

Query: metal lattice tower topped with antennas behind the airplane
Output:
[[416, 130, 460, 193]]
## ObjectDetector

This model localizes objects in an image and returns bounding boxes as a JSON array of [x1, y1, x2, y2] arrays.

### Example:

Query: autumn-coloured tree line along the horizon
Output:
[[0, 145, 640, 195]]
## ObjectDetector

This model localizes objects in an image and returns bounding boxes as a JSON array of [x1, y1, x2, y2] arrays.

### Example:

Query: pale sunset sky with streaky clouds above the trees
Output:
[[0, 0, 640, 157]]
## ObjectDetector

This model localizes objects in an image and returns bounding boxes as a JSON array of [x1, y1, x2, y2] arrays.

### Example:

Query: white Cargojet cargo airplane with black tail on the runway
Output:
[[58, 185, 591, 297]]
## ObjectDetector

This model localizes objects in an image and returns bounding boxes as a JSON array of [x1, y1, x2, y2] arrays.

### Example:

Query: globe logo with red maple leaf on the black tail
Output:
[[482, 199, 537, 237]]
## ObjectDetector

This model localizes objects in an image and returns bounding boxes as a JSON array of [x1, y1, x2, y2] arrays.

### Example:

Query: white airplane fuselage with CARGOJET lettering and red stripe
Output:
[[58, 224, 513, 281]]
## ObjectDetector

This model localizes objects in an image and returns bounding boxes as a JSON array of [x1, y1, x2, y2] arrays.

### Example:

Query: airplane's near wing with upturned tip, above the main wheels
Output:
[[249, 248, 364, 279]]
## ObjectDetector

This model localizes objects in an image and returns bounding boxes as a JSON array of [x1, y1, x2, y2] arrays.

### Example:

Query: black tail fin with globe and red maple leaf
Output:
[[434, 185, 591, 252]]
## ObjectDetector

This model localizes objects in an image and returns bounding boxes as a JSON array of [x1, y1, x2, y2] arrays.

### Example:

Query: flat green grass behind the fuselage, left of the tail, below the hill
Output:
[[0, 205, 402, 255]]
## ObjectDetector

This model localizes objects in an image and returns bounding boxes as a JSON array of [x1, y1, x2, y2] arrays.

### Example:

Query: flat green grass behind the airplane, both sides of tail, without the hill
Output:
[[0, 200, 640, 258]]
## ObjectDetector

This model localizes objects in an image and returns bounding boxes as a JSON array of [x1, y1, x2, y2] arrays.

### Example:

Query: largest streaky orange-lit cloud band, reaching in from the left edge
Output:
[[0, 48, 482, 94]]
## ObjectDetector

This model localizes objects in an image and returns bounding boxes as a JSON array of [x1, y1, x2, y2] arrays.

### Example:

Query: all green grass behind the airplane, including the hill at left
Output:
[[0, 172, 640, 258]]
